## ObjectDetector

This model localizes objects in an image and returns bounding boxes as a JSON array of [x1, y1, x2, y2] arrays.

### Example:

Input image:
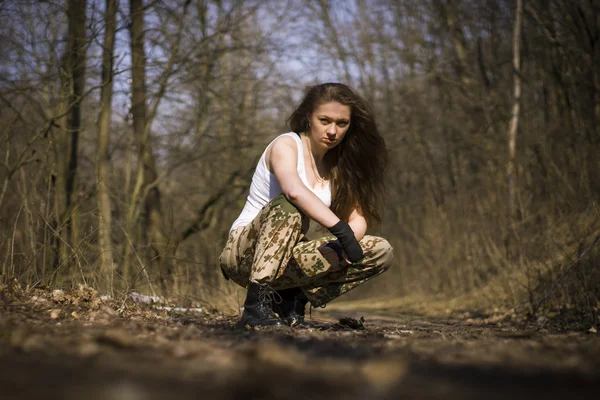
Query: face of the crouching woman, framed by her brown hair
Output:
[[309, 101, 350, 150]]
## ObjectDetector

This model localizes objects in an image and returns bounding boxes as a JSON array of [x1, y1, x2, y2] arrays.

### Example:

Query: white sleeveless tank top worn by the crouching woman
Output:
[[229, 132, 331, 232]]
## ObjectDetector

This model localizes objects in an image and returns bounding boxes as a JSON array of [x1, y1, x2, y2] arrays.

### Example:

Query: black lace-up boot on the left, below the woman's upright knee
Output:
[[238, 282, 286, 327]]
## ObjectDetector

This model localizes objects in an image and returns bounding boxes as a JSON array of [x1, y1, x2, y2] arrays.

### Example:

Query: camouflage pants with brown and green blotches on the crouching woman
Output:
[[219, 195, 393, 307]]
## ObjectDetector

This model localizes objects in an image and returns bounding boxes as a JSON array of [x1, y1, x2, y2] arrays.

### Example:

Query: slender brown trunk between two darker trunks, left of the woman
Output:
[[96, 0, 117, 290]]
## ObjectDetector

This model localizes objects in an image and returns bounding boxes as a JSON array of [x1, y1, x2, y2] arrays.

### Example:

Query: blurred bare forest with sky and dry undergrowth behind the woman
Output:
[[0, 0, 600, 320]]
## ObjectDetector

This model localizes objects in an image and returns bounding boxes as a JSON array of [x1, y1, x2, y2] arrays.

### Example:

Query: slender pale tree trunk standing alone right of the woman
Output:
[[507, 0, 523, 218]]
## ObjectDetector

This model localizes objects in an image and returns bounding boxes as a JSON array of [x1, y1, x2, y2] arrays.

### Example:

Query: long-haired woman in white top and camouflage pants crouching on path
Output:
[[220, 83, 393, 327]]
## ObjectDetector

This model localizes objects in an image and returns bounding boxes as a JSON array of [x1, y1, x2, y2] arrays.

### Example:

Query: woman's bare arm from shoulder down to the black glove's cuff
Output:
[[267, 136, 340, 228]]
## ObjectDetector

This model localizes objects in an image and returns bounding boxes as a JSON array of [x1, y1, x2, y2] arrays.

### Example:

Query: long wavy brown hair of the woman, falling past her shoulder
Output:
[[288, 83, 388, 224]]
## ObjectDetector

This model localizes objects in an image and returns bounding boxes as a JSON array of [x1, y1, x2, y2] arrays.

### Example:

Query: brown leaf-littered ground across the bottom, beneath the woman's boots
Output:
[[0, 288, 600, 400]]
